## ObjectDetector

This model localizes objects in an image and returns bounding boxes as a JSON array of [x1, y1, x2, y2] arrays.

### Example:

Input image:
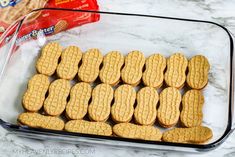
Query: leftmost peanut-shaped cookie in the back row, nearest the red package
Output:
[[36, 42, 62, 76]]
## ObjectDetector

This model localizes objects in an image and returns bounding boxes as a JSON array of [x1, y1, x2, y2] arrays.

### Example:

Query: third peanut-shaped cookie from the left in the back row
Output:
[[78, 49, 103, 83]]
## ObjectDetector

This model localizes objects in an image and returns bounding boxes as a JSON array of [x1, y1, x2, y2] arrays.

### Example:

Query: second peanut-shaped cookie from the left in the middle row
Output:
[[43, 79, 71, 116]]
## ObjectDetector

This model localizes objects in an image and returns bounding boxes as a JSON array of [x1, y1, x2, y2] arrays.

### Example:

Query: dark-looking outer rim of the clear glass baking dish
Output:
[[0, 8, 235, 151]]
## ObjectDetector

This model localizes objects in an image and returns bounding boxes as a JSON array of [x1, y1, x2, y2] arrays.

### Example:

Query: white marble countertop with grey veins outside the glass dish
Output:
[[0, 0, 235, 157]]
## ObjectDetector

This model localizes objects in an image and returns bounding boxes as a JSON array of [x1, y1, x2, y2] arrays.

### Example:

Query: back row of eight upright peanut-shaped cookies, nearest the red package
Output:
[[36, 42, 210, 89]]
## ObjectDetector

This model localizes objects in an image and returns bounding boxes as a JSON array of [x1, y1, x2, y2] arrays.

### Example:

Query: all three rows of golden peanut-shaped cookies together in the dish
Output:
[[18, 42, 212, 143]]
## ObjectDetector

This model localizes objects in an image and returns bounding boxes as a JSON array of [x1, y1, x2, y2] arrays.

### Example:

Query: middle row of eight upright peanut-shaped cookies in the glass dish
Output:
[[22, 74, 204, 127]]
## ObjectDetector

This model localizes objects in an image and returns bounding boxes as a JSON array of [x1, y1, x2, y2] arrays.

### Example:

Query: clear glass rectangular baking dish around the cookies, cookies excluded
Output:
[[0, 8, 234, 152]]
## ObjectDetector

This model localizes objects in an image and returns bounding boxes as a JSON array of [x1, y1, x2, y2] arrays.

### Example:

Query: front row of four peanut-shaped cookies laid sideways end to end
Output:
[[18, 112, 213, 143]]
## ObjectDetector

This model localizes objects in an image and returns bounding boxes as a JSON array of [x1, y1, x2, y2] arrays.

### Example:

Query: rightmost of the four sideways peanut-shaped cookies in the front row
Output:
[[162, 126, 213, 144]]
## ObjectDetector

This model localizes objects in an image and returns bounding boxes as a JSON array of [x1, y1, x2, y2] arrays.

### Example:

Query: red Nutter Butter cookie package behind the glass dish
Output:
[[0, 0, 99, 45]]
